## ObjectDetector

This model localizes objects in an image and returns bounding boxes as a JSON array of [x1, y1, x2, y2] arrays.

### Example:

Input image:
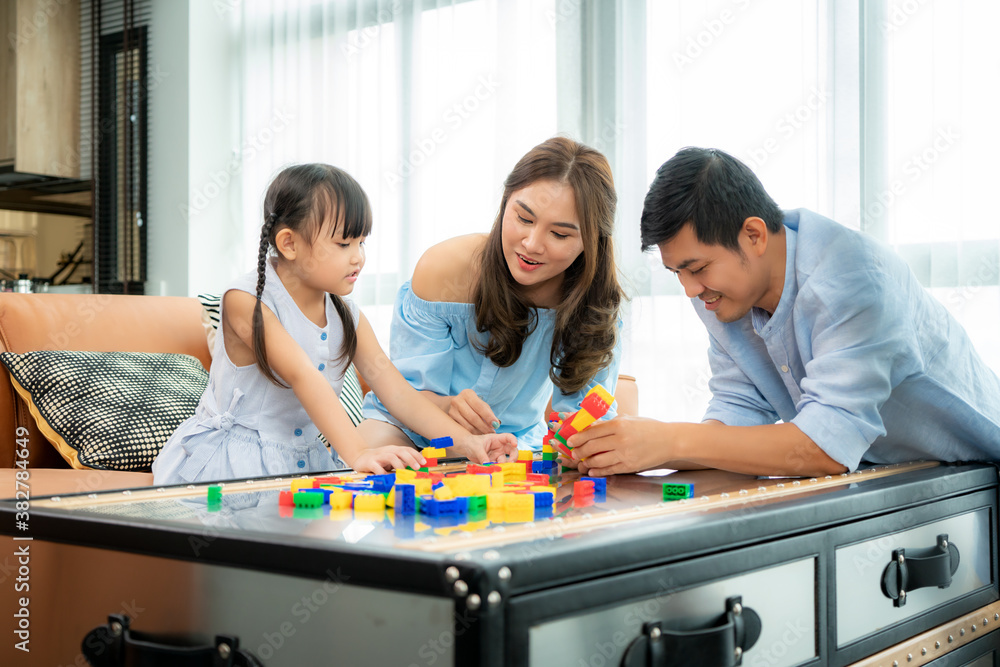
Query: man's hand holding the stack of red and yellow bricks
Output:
[[568, 416, 672, 477]]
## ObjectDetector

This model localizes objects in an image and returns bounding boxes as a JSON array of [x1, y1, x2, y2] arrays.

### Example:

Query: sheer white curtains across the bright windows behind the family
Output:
[[239, 0, 1000, 420]]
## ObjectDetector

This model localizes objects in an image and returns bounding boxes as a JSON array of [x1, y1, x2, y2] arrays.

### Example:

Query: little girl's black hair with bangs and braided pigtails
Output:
[[253, 163, 372, 387]]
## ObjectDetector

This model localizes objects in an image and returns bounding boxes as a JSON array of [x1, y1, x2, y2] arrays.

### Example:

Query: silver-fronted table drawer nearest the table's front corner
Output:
[[508, 539, 825, 667]]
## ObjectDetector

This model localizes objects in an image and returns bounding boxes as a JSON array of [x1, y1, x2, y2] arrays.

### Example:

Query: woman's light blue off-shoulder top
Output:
[[364, 282, 621, 450]]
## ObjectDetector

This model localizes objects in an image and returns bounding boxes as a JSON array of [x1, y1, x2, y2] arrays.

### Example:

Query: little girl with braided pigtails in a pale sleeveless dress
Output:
[[153, 164, 517, 484]]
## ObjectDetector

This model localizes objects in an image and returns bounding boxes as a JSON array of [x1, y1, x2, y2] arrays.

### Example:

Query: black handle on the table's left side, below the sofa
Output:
[[83, 614, 264, 667]]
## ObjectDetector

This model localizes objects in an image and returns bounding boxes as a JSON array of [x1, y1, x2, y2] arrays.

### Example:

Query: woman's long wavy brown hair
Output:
[[473, 137, 623, 394]]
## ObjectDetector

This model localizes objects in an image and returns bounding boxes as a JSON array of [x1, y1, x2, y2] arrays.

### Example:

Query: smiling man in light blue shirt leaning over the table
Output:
[[569, 148, 1000, 476]]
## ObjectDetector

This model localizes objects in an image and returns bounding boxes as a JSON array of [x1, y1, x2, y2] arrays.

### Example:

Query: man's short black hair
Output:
[[639, 147, 784, 251]]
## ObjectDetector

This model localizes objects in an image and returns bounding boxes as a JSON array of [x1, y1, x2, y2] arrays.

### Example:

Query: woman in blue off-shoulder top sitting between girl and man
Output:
[[358, 137, 623, 449]]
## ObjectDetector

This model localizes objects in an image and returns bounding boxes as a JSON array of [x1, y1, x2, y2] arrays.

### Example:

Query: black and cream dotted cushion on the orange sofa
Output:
[[0, 351, 208, 471]]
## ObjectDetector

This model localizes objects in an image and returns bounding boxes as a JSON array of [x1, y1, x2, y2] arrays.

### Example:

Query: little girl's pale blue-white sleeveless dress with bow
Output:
[[153, 260, 358, 484]]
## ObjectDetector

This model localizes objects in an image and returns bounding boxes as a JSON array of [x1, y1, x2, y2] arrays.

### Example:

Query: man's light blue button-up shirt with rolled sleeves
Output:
[[692, 209, 1000, 470]]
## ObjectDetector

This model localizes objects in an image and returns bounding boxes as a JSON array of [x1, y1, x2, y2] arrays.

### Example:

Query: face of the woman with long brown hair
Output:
[[501, 180, 583, 308]]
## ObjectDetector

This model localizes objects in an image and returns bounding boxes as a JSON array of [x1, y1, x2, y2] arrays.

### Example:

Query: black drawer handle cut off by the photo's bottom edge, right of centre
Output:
[[621, 595, 761, 667]]
